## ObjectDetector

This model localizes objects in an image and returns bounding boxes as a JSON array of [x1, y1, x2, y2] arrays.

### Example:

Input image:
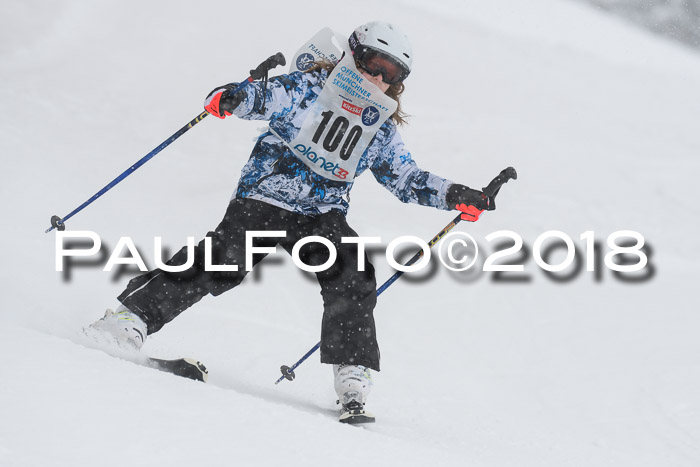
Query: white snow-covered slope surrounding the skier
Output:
[[0, 0, 700, 467]]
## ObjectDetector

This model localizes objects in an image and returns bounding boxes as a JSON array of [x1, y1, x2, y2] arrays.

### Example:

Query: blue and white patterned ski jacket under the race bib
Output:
[[228, 70, 453, 215]]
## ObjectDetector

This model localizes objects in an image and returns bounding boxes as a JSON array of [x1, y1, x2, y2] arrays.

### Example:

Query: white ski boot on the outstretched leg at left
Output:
[[85, 305, 147, 351]]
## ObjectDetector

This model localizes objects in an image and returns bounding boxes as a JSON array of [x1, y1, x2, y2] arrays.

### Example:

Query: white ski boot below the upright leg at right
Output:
[[333, 365, 374, 424]]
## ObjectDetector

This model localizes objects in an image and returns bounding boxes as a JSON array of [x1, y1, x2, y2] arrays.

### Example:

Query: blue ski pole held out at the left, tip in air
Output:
[[44, 52, 286, 233]]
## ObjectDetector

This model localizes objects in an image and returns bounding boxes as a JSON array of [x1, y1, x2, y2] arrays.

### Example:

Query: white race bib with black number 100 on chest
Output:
[[288, 31, 397, 182]]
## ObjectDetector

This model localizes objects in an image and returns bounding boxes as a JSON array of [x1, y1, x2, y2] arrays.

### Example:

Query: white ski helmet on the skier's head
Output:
[[348, 21, 413, 82]]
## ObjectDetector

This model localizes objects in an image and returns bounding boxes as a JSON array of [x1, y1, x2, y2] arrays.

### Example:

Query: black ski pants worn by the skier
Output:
[[118, 199, 379, 370]]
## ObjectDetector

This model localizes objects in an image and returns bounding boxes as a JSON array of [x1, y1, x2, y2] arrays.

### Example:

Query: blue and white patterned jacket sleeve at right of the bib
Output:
[[370, 125, 454, 210]]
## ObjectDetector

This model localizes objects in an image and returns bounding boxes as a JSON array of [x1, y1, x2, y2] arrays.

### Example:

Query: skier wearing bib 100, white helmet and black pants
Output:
[[91, 22, 490, 423]]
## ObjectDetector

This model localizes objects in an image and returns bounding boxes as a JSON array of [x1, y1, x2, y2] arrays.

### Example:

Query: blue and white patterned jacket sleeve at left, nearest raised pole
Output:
[[227, 72, 320, 120]]
